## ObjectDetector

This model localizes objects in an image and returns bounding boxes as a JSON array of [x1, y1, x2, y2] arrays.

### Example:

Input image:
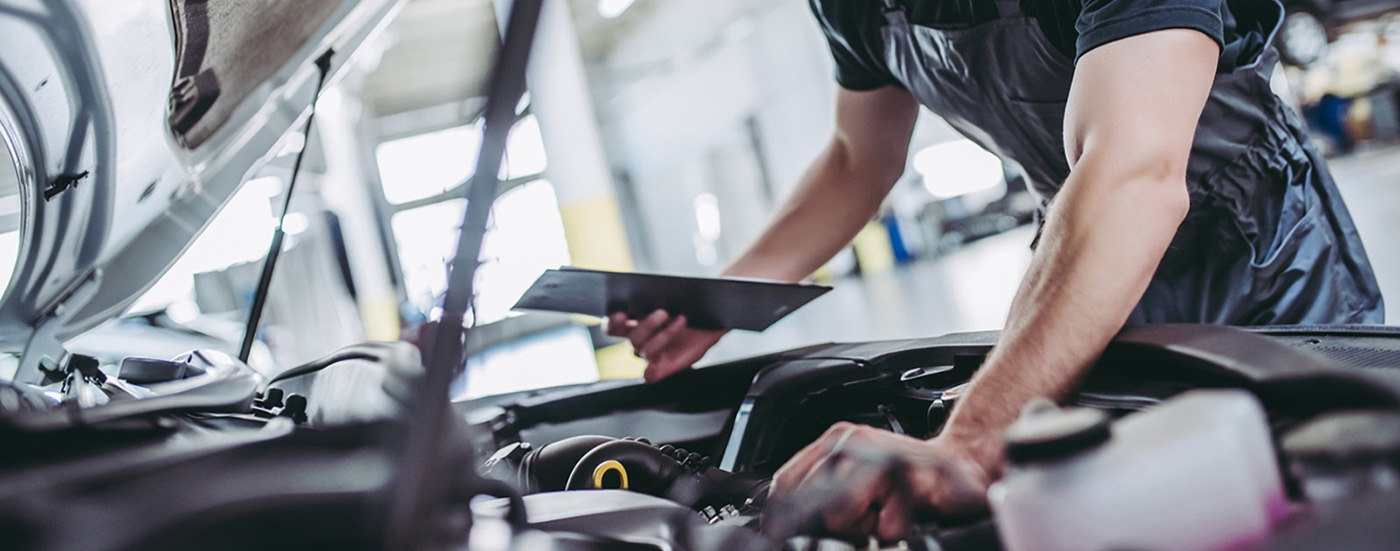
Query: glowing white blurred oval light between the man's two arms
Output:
[[914, 140, 1005, 199]]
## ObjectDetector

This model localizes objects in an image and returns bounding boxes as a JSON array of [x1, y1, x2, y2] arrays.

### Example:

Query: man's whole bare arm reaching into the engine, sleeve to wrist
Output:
[[939, 29, 1219, 466]]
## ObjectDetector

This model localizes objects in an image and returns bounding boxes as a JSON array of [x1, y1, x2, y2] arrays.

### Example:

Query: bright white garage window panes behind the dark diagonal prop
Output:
[[377, 115, 598, 399]]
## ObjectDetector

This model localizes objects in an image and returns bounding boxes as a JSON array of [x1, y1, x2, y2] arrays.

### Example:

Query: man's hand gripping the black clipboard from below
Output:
[[608, 310, 724, 382]]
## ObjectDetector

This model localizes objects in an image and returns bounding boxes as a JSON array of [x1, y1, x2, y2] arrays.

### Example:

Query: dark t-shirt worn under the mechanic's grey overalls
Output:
[[809, 0, 1278, 91]]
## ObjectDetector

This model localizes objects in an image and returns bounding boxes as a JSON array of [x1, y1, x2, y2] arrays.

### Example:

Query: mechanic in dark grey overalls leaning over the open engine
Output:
[[609, 0, 1383, 540]]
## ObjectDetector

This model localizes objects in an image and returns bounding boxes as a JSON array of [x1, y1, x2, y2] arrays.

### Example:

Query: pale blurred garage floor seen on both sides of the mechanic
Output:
[[701, 147, 1400, 364]]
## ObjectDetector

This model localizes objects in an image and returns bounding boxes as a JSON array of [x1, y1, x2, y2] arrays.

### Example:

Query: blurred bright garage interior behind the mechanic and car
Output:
[[54, 0, 1400, 396]]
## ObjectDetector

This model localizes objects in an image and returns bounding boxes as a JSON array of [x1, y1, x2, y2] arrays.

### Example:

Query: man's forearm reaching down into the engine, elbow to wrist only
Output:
[[941, 164, 1189, 466]]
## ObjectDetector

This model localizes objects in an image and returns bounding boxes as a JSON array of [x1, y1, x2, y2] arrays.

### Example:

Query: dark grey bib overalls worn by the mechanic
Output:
[[882, 0, 1385, 326]]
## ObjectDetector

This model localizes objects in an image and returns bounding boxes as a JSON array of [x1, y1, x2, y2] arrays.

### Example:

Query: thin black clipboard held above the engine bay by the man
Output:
[[514, 267, 832, 331]]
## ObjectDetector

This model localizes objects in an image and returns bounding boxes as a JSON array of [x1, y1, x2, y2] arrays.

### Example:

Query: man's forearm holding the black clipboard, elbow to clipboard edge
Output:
[[725, 141, 899, 281]]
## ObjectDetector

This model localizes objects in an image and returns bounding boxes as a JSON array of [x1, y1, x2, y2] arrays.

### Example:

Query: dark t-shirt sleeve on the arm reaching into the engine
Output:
[[1075, 0, 1229, 59]]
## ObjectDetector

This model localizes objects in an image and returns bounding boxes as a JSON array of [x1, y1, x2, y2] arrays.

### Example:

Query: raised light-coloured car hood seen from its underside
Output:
[[0, 0, 402, 380]]
